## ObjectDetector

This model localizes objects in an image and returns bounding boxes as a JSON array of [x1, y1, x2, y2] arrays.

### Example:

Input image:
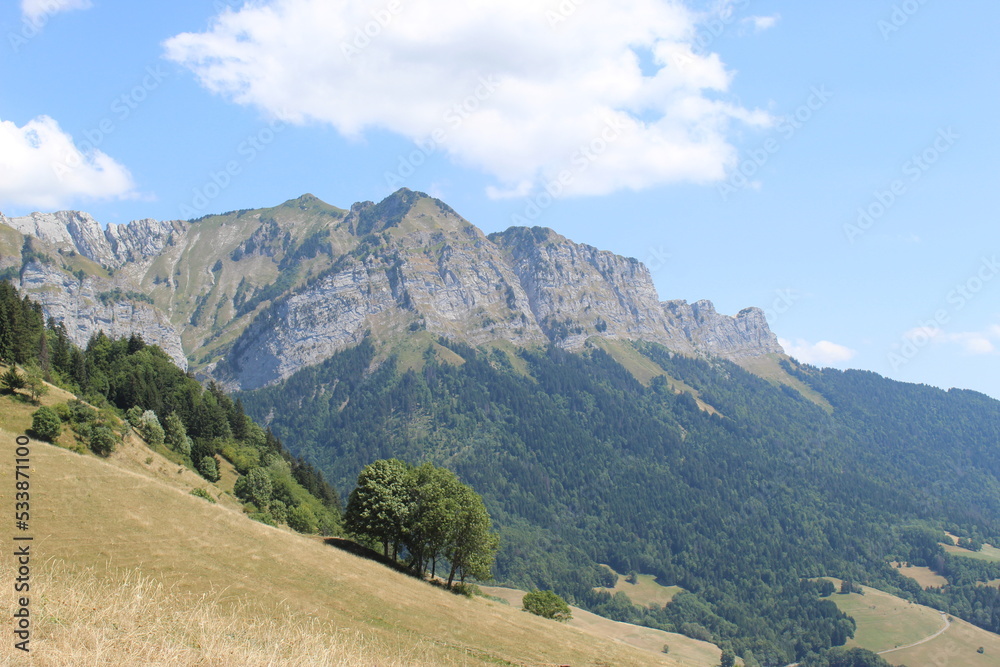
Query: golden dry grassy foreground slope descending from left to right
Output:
[[0, 396, 696, 666]]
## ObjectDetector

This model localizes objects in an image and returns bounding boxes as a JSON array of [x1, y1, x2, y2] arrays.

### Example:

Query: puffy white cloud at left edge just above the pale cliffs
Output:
[[0, 116, 135, 210]]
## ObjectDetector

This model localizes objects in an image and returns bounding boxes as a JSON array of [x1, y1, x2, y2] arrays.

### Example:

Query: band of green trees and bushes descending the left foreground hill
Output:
[[0, 281, 341, 535]]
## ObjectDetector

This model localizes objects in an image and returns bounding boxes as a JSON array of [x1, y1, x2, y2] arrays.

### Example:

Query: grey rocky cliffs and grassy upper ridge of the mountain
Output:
[[0, 189, 782, 389]]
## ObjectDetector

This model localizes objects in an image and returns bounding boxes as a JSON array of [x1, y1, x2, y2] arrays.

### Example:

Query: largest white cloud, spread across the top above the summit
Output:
[[165, 0, 771, 197]]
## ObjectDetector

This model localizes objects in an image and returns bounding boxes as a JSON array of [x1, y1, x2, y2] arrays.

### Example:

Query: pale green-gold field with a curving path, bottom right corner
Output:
[[830, 579, 1000, 667]]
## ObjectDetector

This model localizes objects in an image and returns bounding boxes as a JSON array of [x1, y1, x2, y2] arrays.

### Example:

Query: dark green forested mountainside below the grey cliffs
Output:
[[242, 339, 1000, 665]]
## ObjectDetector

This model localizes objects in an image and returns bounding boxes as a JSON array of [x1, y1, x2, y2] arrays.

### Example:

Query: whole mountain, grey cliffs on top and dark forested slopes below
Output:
[[0, 190, 1000, 667]]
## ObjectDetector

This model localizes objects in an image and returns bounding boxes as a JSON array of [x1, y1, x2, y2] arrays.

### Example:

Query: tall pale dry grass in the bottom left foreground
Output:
[[0, 560, 406, 667]]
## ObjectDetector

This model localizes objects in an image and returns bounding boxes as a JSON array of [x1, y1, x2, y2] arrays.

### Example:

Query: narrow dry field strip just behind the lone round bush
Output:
[[481, 586, 722, 667]]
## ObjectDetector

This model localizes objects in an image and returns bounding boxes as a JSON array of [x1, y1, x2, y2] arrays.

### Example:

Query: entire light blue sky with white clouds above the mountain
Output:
[[0, 0, 1000, 398]]
